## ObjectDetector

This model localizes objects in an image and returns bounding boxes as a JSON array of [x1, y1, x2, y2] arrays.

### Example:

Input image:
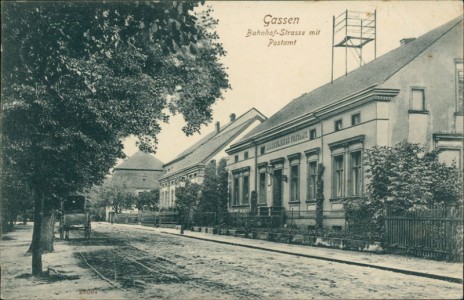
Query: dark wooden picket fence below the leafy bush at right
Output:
[[384, 207, 463, 261]]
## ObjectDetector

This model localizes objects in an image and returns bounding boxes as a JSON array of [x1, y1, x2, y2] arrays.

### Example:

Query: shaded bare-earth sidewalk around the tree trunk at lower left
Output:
[[0, 223, 131, 300]]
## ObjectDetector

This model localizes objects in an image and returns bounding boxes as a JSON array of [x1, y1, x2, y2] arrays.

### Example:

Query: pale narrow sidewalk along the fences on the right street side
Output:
[[102, 223, 463, 284]]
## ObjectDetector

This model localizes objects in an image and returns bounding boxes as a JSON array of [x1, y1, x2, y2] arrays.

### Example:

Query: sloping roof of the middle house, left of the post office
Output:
[[162, 108, 266, 178]]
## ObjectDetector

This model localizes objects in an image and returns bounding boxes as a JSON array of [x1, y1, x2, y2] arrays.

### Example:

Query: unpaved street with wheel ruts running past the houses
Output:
[[72, 223, 462, 299]]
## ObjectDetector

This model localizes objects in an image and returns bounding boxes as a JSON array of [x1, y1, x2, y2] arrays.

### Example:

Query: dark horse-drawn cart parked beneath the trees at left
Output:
[[60, 196, 91, 240]]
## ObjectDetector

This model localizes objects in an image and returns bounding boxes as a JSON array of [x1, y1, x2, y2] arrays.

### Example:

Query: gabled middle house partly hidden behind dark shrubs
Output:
[[160, 108, 266, 208]]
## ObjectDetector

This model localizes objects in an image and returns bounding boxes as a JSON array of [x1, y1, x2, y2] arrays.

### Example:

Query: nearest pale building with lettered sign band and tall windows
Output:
[[227, 17, 463, 227]]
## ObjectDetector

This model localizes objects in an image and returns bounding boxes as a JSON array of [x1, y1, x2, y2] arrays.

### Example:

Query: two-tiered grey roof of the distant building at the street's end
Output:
[[111, 151, 163, 194]]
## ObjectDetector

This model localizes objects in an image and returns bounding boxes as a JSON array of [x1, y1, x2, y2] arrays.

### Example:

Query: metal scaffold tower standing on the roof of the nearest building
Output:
[[331, 10, 377, 81]]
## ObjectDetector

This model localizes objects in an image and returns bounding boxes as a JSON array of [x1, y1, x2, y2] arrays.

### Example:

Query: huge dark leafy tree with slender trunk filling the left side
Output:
[[1, 1, 229, 275]]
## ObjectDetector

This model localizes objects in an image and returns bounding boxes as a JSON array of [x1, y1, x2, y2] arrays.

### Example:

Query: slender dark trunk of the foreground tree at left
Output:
[[30, 193, 44, 276]]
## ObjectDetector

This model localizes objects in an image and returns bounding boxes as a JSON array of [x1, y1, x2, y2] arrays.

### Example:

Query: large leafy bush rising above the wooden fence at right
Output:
[[345, 141, 463, 234]]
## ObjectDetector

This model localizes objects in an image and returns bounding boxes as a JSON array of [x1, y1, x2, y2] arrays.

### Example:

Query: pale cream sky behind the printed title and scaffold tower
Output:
[[121, 1, 463, 163]]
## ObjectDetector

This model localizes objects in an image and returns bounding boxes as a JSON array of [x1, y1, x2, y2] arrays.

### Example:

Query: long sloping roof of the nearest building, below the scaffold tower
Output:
[[240, 16, 462, 142]]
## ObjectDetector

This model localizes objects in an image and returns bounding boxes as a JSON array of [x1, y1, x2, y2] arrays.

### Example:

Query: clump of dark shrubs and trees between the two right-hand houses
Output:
[[175, 159, 228, 226]]
